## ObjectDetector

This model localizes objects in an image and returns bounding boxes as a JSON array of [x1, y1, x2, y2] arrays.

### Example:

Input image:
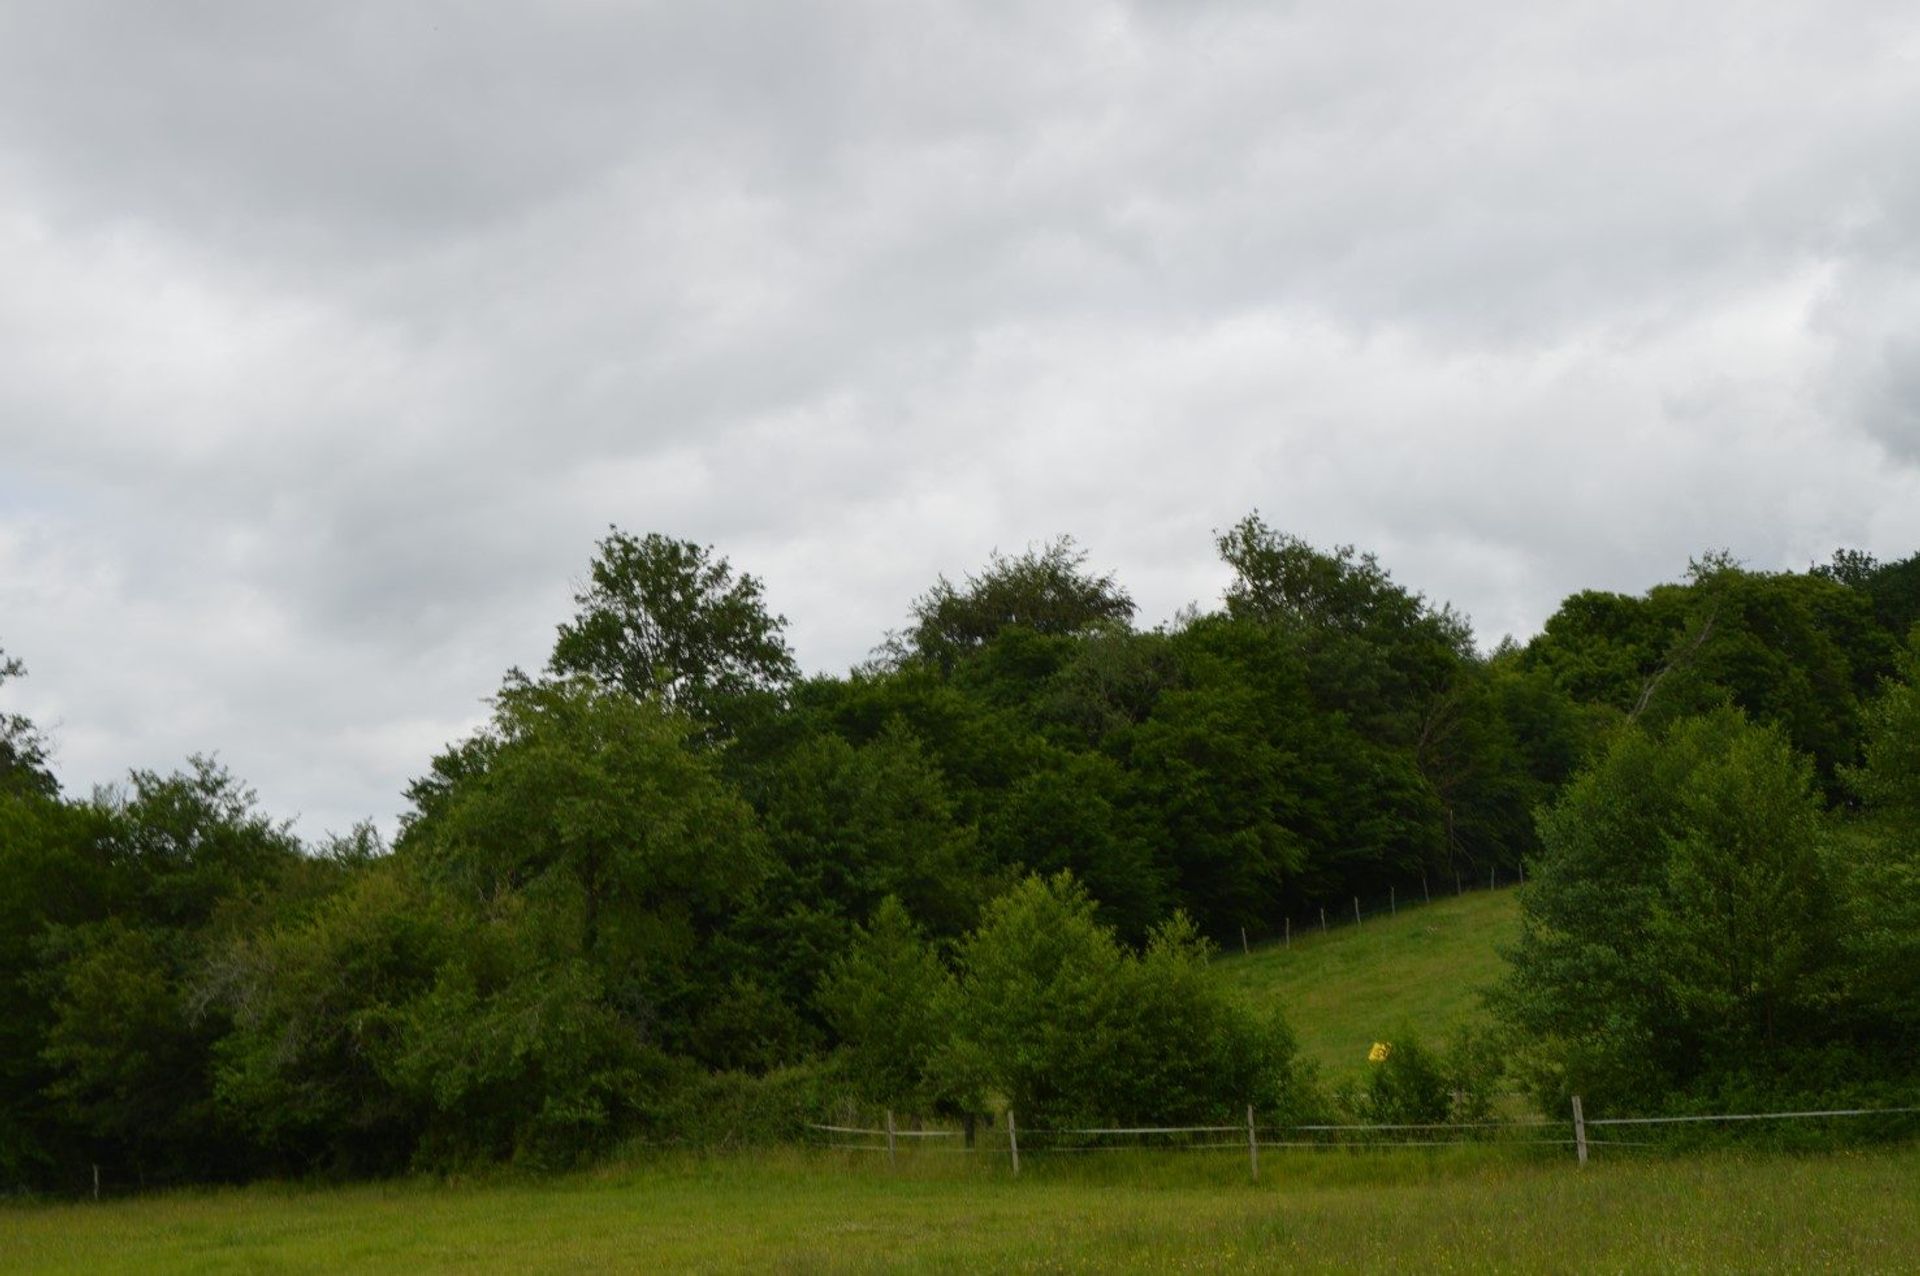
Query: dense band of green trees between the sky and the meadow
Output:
[[0, 516, 1920, 1188]]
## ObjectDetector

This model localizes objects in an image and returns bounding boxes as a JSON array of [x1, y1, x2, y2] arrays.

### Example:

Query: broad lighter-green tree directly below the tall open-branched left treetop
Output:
[[396, 677, 768, 1052]]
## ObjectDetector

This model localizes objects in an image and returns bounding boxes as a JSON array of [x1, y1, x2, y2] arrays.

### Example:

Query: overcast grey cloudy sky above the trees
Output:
[[0, 0, 1920, 839]]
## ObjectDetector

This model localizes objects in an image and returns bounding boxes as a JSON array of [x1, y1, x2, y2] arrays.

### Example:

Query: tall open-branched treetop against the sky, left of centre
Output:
[[549, 528, 799, 725]]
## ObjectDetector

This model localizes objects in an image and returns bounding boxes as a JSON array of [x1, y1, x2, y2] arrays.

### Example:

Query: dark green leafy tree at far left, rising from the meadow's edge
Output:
[[4, 758, 300, 1182]]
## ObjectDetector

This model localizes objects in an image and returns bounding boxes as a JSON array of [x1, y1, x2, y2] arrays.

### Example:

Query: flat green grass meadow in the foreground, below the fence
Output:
[[0, 1147, 1920, 1274]]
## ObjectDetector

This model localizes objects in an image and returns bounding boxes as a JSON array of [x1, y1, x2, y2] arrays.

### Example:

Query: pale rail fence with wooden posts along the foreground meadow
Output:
[[808, 1096, 1920, 1180]]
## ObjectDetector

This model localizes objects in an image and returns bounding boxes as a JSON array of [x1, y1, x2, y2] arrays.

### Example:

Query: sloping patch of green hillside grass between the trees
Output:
[[1215, 890, 1521, 1084]]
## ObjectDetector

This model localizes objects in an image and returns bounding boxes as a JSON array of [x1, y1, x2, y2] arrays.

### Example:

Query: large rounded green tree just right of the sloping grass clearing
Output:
[[1498, 710, 1839, 1109]]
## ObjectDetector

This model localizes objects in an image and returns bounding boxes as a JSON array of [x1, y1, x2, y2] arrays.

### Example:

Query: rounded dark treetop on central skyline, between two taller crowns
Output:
[[906, 535, 1133, 672]]
